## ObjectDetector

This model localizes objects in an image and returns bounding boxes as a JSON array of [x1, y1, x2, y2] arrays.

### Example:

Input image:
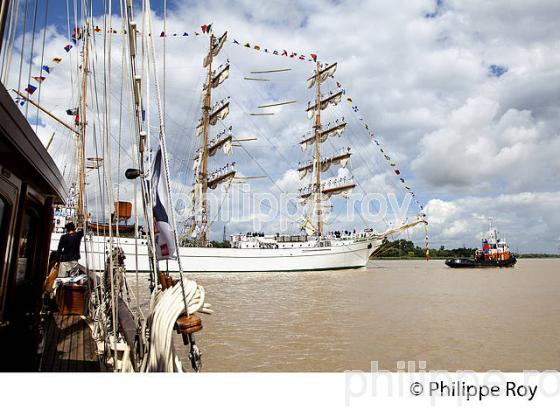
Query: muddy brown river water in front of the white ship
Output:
[[129, 259, 560, 372]]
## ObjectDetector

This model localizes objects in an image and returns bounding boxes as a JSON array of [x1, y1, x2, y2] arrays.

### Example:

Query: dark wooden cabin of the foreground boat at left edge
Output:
[[0, 84, 66, 371]]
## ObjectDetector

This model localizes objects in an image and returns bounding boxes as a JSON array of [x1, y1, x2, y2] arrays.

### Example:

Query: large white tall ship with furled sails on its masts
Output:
[[51, 32, 426, 272]]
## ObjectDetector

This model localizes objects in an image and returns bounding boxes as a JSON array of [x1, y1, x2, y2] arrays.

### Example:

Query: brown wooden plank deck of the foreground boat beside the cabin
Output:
[[39, 313, 100, 372]]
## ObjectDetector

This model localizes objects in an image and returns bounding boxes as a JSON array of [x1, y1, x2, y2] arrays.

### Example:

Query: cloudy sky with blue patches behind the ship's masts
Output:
[[1, 0, 560, 253]]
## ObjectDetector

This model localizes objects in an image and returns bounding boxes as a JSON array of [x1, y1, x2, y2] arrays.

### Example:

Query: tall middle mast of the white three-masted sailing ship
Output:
[[197, 34, 214, 246]]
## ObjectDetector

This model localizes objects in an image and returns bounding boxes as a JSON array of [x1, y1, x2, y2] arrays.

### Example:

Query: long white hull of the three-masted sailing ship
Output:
[[51, 233, 381, 272]]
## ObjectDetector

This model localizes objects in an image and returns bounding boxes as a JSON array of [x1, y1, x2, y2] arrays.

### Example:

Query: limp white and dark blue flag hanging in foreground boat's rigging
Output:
[[151, 148, 177, 260]]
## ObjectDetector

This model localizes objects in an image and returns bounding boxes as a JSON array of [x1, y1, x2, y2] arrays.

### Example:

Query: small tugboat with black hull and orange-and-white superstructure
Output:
[[445, 222, 517, 268]]
